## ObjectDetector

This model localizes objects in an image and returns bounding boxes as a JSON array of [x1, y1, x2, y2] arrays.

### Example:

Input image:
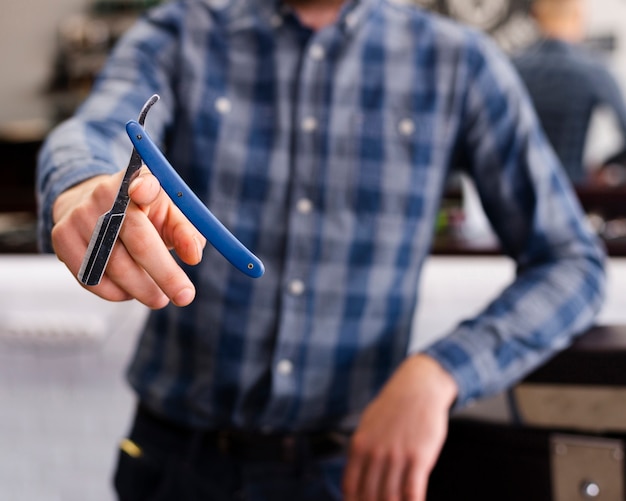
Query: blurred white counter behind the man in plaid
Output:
[[0, 254, 626, 501]]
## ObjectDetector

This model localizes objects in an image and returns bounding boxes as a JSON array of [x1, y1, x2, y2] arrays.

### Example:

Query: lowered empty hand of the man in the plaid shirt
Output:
[[344, 355, 457, 501]]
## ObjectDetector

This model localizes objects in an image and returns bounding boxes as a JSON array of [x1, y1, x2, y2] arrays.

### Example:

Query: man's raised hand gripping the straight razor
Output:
[[52, 167, 206, 309]]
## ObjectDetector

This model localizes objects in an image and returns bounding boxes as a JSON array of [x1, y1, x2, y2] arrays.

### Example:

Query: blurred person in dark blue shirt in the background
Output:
[[514, 0, 626, 184]]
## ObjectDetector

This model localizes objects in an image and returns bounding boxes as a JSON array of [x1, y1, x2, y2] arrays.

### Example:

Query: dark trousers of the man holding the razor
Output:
[[114, 407, 348, 501]]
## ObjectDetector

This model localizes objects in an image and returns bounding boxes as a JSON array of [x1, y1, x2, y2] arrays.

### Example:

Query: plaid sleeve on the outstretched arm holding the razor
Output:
[[36, 3, 180, 252]]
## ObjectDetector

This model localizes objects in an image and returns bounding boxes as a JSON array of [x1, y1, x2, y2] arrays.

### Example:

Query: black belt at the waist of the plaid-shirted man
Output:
[[133, 405, 350, 462]]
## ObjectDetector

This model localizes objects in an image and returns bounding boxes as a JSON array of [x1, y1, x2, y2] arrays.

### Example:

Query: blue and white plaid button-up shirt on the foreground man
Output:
[[38, 0, 604, 430]]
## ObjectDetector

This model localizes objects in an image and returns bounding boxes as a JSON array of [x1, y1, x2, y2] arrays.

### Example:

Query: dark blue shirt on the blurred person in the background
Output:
[[513, 38, 626, 183]]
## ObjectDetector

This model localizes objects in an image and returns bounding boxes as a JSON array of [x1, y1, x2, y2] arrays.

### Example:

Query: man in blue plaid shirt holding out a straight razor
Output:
[[38, 0, 604, 501]]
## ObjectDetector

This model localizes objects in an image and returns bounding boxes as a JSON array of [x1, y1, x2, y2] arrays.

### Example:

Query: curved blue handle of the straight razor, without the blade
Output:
[[126, 120, 265, 278]]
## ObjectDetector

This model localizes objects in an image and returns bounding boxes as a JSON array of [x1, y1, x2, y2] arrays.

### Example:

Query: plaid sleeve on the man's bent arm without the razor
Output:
[[425, 32, 605, 407]]
